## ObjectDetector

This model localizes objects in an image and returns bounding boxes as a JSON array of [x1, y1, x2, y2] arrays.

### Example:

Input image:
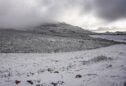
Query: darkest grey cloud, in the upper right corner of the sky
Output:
[[94, 0, 126, 21]]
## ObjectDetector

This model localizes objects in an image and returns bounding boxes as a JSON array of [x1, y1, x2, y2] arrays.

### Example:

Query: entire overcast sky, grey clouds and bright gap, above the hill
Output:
[[0, 0, 126, 31]]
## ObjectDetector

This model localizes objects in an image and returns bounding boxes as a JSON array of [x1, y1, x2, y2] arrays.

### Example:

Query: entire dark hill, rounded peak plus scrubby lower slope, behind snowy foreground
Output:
[[0, 24, 120, 53]]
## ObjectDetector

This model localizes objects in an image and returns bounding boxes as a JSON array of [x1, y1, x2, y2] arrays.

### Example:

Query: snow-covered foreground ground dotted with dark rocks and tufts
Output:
[[0, 44, 126, 86]]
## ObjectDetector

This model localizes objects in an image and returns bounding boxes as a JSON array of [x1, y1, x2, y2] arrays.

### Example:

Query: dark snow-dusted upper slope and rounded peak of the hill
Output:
[[30, 23, 92, 39]]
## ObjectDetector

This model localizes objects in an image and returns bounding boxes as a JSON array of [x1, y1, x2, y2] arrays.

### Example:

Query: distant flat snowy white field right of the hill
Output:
[[90, 35, 126, 43]]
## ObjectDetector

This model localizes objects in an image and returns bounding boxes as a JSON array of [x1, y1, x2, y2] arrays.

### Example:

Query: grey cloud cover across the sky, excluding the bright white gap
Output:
[[0, 0, 126, 28]]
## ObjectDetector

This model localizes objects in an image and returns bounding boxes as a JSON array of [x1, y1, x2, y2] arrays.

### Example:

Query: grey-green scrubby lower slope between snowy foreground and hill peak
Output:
[[0, 30, 116, 53]]
